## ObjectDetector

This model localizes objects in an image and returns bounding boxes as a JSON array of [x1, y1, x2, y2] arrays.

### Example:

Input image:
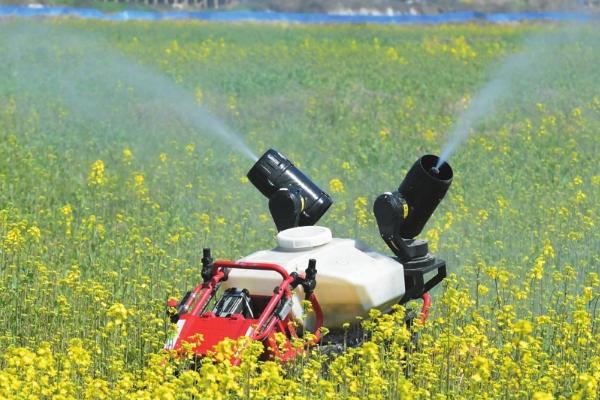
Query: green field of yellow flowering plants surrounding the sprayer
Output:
[[0, 19, 600, 400]]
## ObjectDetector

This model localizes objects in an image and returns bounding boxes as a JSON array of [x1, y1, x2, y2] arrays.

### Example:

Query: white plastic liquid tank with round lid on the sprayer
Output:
[[224, 226, 405, 328]]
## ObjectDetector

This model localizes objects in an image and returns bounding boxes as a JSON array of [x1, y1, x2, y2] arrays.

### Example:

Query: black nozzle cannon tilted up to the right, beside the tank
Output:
[[373, 155, 453, 262]]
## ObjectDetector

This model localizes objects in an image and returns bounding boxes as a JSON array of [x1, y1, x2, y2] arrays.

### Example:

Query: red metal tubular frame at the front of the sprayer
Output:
[[165, 260, 323, 364]]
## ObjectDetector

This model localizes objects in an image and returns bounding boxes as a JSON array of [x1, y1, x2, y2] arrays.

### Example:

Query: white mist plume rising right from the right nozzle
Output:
[[436, 24, 600, 168]]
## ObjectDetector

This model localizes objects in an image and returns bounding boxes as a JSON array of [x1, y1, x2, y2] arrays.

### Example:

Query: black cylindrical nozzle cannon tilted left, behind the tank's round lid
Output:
[[247, 149, 333, 231]]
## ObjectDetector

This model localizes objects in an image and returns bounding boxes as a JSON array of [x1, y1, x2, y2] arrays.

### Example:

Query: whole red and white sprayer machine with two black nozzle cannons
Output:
[[165, 150, 453, 363]]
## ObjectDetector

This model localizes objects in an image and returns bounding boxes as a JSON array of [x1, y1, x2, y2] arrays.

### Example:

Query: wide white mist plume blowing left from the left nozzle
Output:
[[0, 20, 258, 161]]
